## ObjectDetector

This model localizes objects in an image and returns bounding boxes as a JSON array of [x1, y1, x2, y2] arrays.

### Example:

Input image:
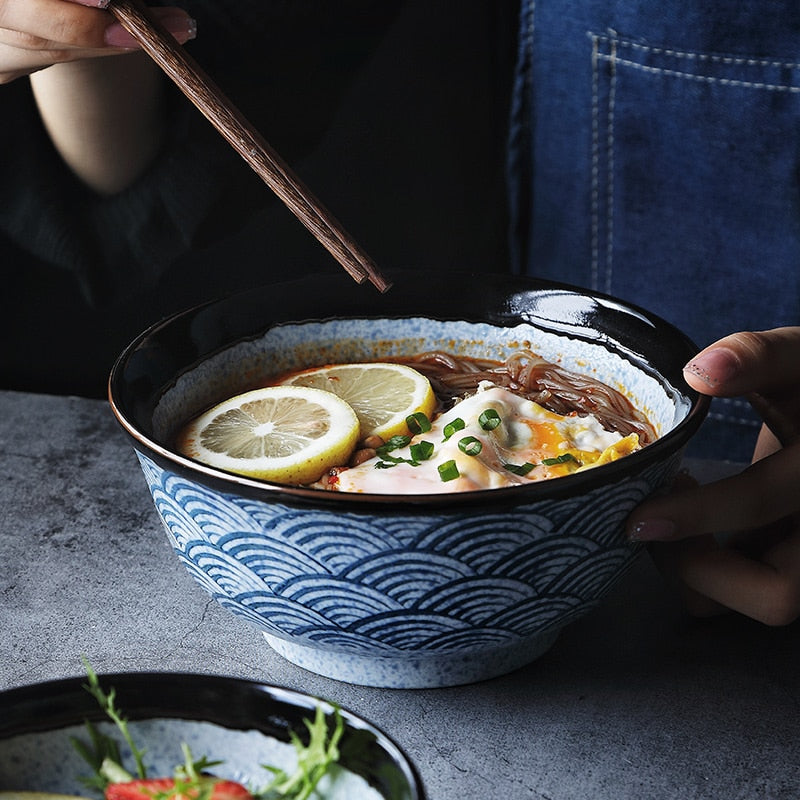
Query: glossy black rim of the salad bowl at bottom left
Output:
[[0, 672, 425, 800]]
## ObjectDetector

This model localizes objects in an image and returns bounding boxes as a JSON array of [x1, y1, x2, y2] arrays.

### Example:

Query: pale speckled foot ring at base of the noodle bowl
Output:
[[264, 629, 559, 689]]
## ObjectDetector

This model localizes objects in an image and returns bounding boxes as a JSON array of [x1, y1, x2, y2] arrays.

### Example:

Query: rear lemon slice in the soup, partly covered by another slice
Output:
[[285, 363, 436, 440]]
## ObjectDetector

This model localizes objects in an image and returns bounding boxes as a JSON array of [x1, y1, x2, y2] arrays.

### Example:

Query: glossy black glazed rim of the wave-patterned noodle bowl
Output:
[[109, 270, 709, 513]]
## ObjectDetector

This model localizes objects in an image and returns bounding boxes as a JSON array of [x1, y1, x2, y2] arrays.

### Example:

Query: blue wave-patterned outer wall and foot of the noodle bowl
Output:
[[138, 453, 680, 688]]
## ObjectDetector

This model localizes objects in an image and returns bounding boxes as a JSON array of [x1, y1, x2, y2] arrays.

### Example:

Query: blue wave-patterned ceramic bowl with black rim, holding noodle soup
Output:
[[110, 272, 706, 688]]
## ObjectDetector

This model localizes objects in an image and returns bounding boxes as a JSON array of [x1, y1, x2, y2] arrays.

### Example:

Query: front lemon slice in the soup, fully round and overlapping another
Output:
[[176, 386, 359, 484]]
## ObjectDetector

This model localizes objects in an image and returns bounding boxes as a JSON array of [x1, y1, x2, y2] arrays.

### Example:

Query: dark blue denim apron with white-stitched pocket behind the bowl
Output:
[[509, 0, 800, 460]]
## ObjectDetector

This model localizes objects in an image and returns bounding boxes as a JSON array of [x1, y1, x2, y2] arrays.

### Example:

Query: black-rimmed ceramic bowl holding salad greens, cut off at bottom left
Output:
[[0, 673, 425, 800]]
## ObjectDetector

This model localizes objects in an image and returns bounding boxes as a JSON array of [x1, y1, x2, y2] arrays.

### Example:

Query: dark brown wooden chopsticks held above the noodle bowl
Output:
[[108, 0, 391, 292]]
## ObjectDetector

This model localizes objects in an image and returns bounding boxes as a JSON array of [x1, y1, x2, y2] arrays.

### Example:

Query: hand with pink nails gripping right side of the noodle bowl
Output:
[[628, 327, 800, 625]]
